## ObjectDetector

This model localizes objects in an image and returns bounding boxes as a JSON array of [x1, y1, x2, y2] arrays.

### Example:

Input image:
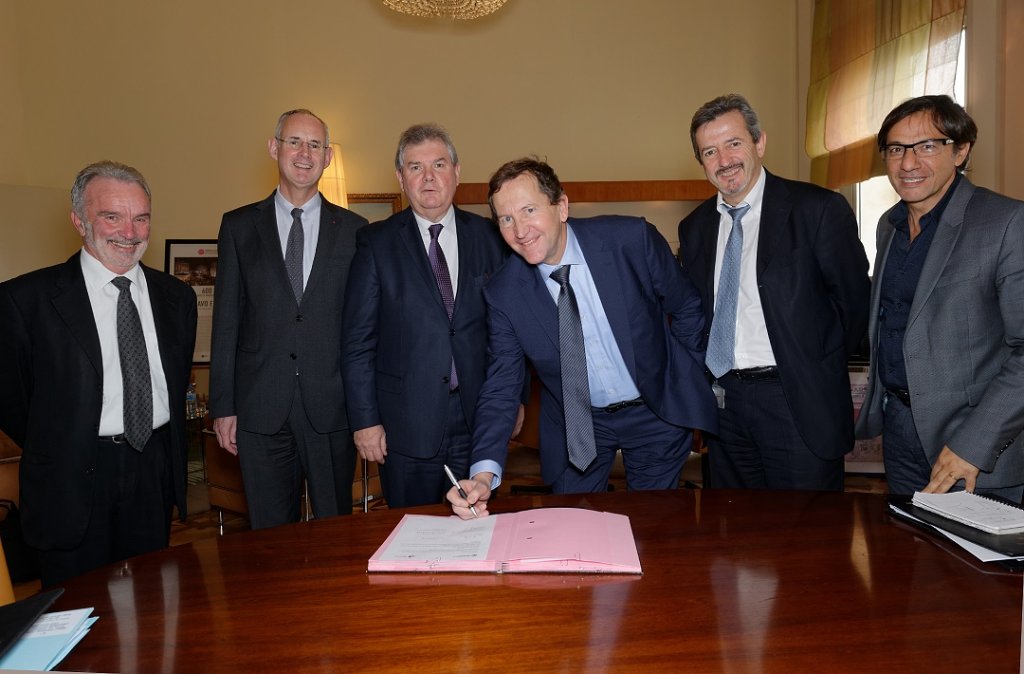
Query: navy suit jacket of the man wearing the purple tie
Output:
[[342, 208, 509, 458]]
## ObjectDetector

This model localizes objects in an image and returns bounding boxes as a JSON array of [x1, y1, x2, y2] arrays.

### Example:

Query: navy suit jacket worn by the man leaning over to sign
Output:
[[470, 216, 718, 483]]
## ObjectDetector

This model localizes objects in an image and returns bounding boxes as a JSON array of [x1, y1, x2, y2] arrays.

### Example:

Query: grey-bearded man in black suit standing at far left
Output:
[[0, 162, 196, 587]]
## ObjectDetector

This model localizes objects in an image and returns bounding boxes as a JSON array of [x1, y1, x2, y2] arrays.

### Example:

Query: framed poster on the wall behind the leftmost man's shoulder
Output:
[[164, 239, 217, 363]]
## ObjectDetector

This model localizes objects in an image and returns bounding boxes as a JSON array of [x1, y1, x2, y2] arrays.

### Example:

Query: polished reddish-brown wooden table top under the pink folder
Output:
[[46, 490, 1024, 674]]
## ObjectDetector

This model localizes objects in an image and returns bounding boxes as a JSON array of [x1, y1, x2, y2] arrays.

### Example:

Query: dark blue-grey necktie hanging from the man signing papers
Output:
[[551, 264, 597, 470]]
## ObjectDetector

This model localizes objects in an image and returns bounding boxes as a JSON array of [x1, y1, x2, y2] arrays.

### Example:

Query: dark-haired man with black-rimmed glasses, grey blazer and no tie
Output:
[[856, 95, 1024, 495]]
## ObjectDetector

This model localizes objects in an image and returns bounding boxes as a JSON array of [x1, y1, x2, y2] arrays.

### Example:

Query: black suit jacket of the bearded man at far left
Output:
[[0, 253, 196, 550]]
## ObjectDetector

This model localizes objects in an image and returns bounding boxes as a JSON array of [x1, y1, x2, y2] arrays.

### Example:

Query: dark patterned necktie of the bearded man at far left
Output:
[[111, 277, 153, 452]]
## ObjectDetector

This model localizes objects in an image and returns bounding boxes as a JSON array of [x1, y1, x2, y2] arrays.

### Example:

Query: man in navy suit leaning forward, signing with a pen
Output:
[[447, 159, 716, 517]]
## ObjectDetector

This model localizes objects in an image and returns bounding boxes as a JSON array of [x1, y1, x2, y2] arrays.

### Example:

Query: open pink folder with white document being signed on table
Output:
[[367, 508, 643, 574]]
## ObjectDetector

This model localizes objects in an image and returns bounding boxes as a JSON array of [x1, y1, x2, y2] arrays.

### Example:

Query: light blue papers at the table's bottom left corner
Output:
[[0, 607, 99, 672]]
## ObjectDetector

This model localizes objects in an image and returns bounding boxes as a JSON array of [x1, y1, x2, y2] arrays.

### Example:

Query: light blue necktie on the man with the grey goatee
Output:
[[705, 204, 751, 378]]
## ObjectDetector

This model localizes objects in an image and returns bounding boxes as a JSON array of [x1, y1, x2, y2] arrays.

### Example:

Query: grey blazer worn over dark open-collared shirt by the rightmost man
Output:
[[856, 178, 1024, 489]]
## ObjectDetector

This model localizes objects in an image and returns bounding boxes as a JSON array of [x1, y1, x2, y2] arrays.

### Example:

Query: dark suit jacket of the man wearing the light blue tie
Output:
[[679, 171, 870, 459]]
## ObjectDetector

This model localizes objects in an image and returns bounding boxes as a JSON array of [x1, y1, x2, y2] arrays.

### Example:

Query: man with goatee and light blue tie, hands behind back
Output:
[[679, 94, 869, 491]]
